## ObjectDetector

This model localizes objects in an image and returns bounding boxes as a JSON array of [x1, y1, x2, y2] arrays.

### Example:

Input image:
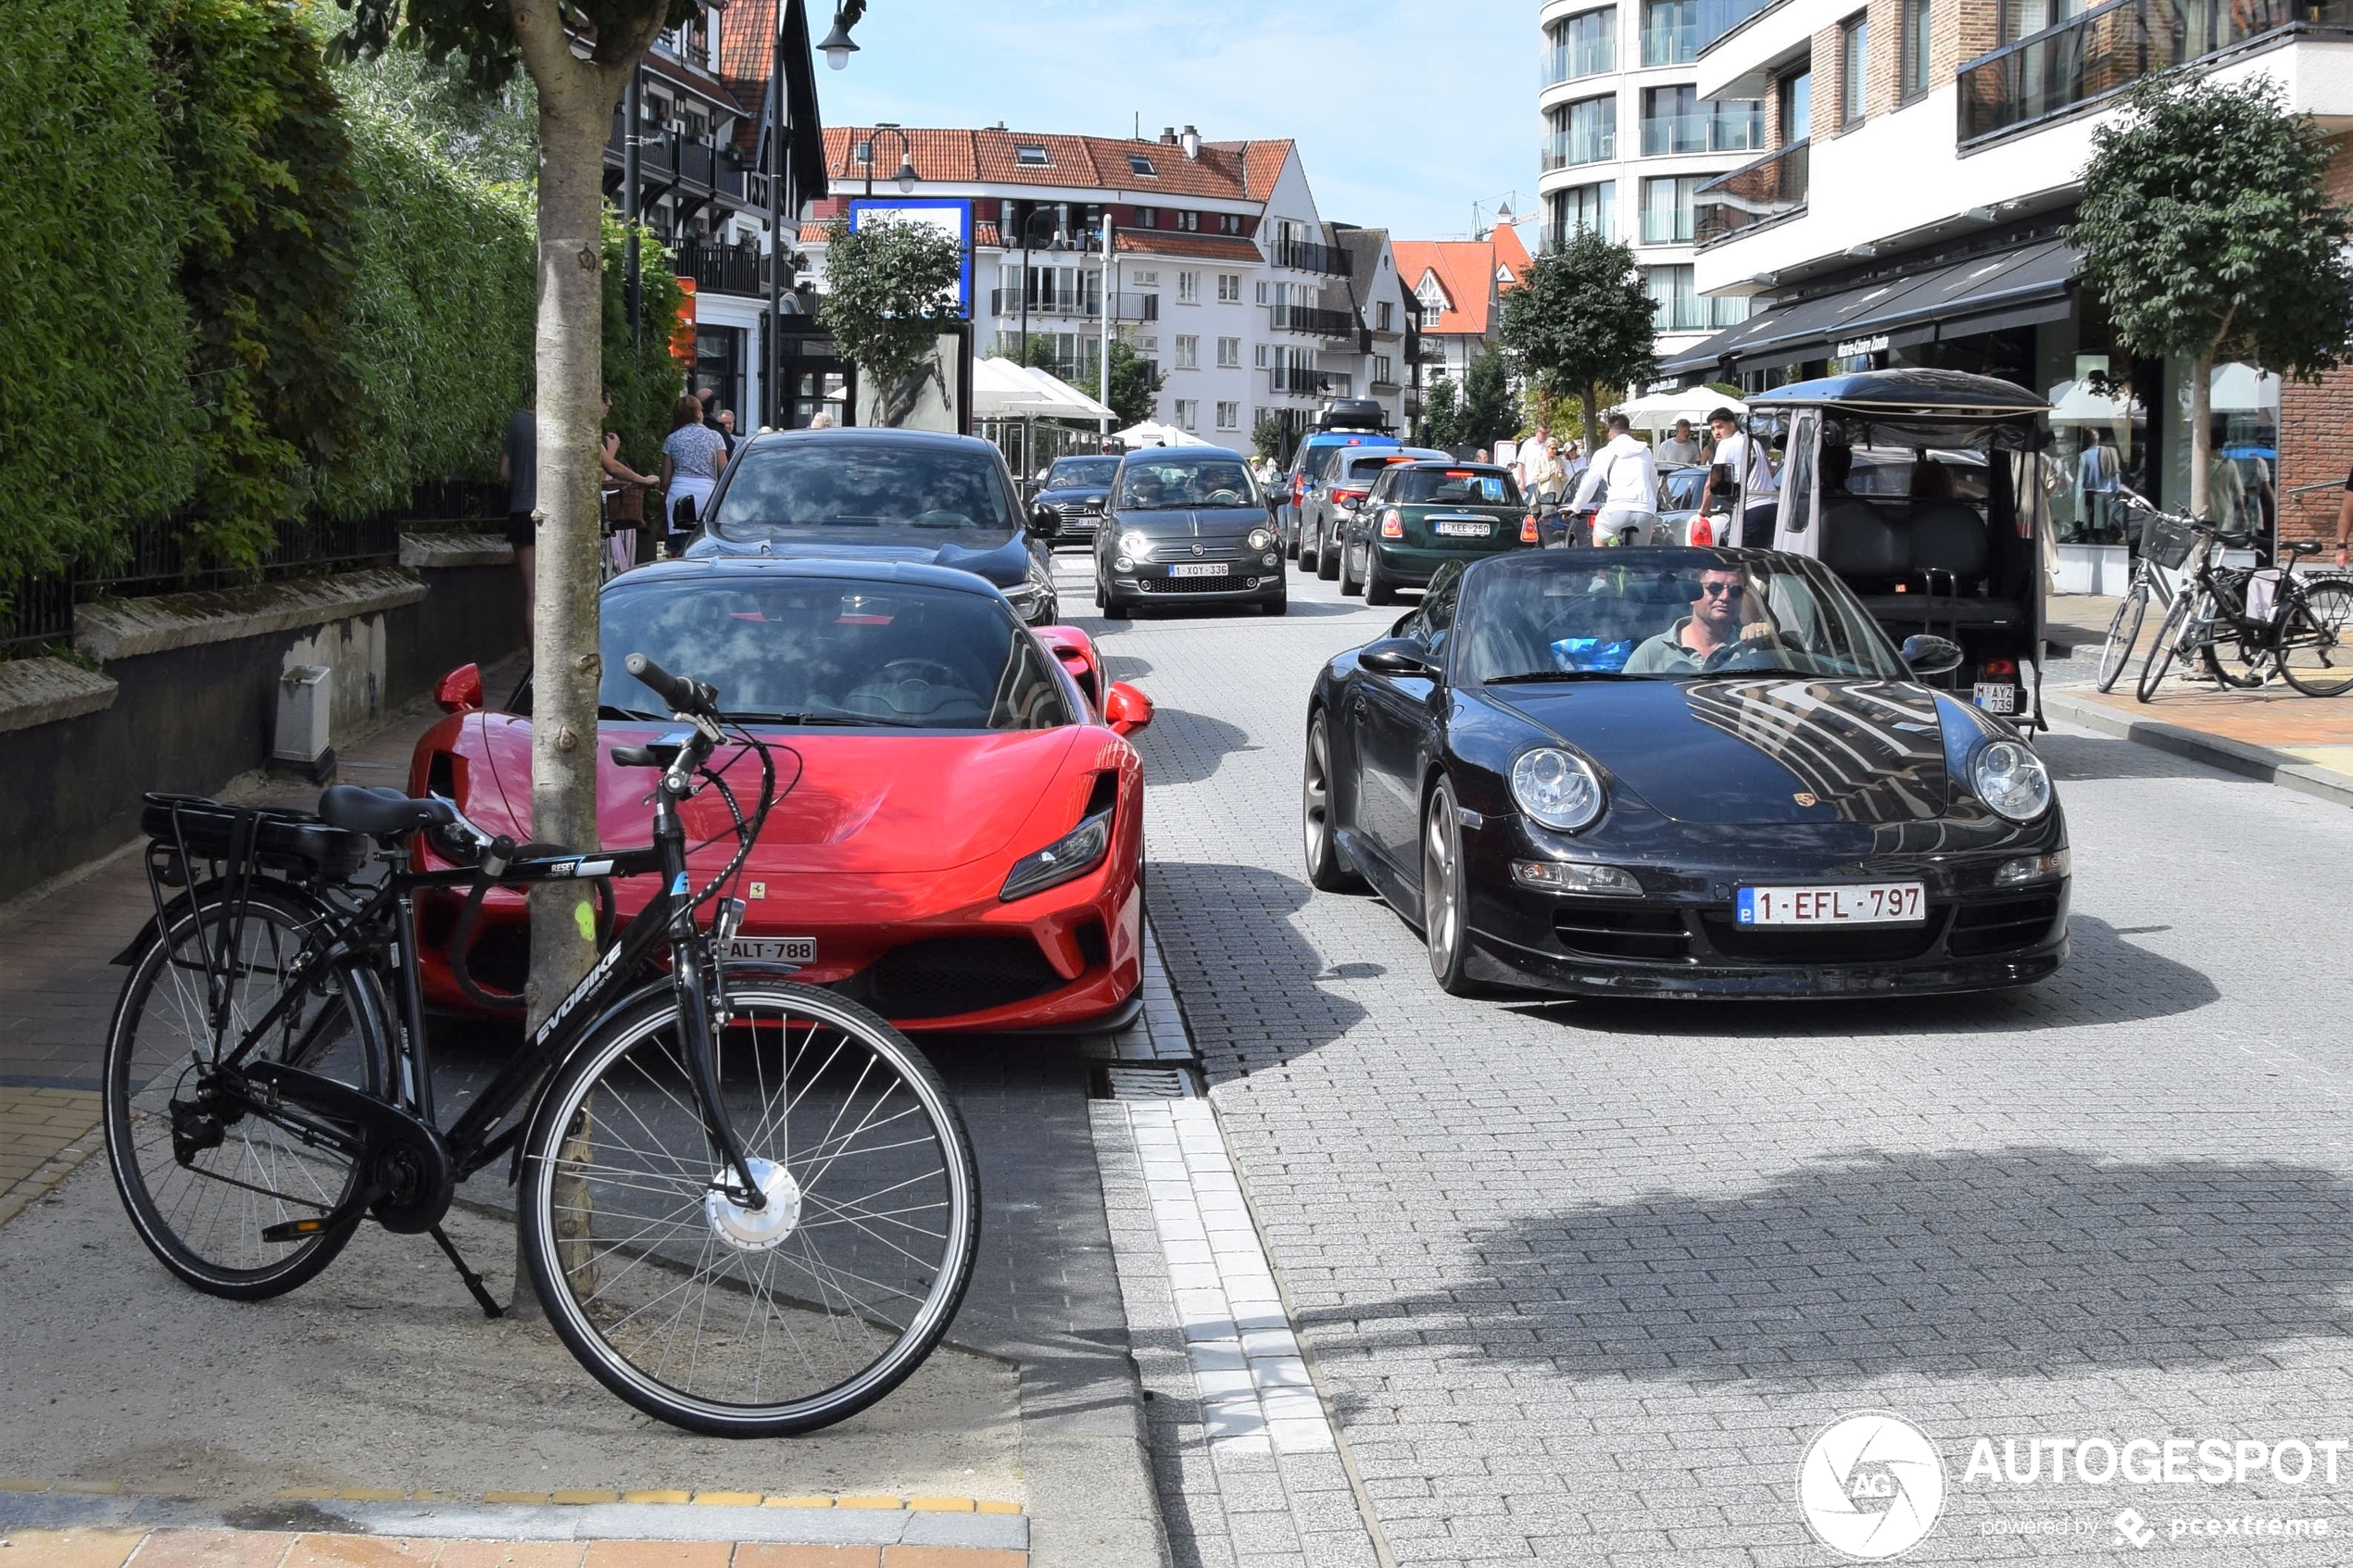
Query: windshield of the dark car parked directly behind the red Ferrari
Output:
[[713, 440, 1014, 538]]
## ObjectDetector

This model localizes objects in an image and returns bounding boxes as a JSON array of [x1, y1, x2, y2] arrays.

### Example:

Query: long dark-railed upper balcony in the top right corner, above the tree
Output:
[[1960, 0, 2353, 145]]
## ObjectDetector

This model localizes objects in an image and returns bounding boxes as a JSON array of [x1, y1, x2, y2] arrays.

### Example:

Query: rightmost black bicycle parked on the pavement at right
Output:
[[2139, 503, 2353, 703]]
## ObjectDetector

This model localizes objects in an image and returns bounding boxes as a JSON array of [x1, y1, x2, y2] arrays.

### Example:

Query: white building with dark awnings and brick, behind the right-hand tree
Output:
[[1661, 0, 2353, 546]]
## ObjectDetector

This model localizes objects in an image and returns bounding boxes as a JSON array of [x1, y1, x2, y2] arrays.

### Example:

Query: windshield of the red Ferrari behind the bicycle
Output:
[[598, 571, 1071, 729]]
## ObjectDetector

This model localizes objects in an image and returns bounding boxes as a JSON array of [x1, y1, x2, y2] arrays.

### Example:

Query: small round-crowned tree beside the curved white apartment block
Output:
[[1496, 228, 1659, 451]]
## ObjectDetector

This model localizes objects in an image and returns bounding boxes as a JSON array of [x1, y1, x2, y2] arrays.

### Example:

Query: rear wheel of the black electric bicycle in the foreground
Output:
[[101, 884, 384, 1300]]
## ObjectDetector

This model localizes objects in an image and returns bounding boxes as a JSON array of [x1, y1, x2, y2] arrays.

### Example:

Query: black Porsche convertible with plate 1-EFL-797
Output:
[[1302, 547, 2069, 997]]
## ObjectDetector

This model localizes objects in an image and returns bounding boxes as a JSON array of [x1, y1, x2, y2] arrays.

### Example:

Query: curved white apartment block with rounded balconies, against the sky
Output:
[[1537, 0, 1768, 353]]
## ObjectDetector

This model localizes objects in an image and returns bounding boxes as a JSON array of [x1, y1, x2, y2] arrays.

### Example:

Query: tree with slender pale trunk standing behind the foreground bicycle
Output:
[[339, 0, 700, 1027]]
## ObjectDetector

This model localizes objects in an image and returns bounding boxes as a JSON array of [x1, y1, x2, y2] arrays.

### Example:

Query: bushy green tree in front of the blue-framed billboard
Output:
[[816, 217, 964, 425]]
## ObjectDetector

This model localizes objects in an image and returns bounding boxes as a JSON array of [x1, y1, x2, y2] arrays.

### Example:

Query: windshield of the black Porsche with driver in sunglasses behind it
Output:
[[1456, 547, 1910, 684]]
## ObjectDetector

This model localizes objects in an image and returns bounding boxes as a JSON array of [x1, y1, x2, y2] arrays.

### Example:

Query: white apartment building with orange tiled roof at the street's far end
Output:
[[796, 125, 1404, 449]]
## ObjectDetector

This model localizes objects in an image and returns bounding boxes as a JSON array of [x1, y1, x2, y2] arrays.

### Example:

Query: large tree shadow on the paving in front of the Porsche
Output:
[[1302, 1142, 2353, 1420]]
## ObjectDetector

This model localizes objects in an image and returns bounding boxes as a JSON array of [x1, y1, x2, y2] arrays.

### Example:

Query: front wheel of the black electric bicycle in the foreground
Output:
[[520, 978, 981, 1436]]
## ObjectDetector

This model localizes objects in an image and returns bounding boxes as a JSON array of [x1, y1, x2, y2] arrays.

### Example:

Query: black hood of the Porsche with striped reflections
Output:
[[1487, 674, 1951, 825]]
